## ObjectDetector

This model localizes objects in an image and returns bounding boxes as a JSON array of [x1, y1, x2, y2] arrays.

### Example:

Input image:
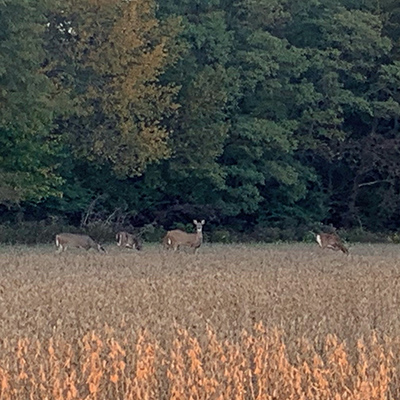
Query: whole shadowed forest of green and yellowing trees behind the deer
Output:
[[0, 0, 400, 242]]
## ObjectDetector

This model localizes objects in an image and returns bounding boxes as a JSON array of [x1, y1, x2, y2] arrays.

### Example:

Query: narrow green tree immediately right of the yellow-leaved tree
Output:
[[160, 0, 238, 206]]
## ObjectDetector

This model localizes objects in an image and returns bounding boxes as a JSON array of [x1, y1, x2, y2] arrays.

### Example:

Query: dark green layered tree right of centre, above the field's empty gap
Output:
[[214, 0, 314, 227]]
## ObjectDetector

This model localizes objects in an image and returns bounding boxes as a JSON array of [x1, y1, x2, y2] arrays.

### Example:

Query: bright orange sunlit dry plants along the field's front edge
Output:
[[0, 323, 400, 400]]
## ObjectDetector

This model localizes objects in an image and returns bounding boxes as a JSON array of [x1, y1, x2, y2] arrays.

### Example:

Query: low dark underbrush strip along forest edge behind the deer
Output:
[[0, 220, 392, 244]]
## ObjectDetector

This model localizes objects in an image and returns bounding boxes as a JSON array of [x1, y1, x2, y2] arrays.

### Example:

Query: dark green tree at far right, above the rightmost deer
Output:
[[286, 2, 400, 228]]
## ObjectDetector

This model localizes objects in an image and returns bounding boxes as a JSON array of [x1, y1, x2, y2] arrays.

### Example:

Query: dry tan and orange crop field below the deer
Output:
[[0, 244, 400, 400]]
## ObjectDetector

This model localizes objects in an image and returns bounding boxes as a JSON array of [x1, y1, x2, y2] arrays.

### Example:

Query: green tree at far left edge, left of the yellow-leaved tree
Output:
[[0, 0, 68, 203]]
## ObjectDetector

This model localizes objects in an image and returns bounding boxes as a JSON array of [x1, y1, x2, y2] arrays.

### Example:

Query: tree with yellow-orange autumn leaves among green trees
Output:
[[46, 0, 180, 177]]
